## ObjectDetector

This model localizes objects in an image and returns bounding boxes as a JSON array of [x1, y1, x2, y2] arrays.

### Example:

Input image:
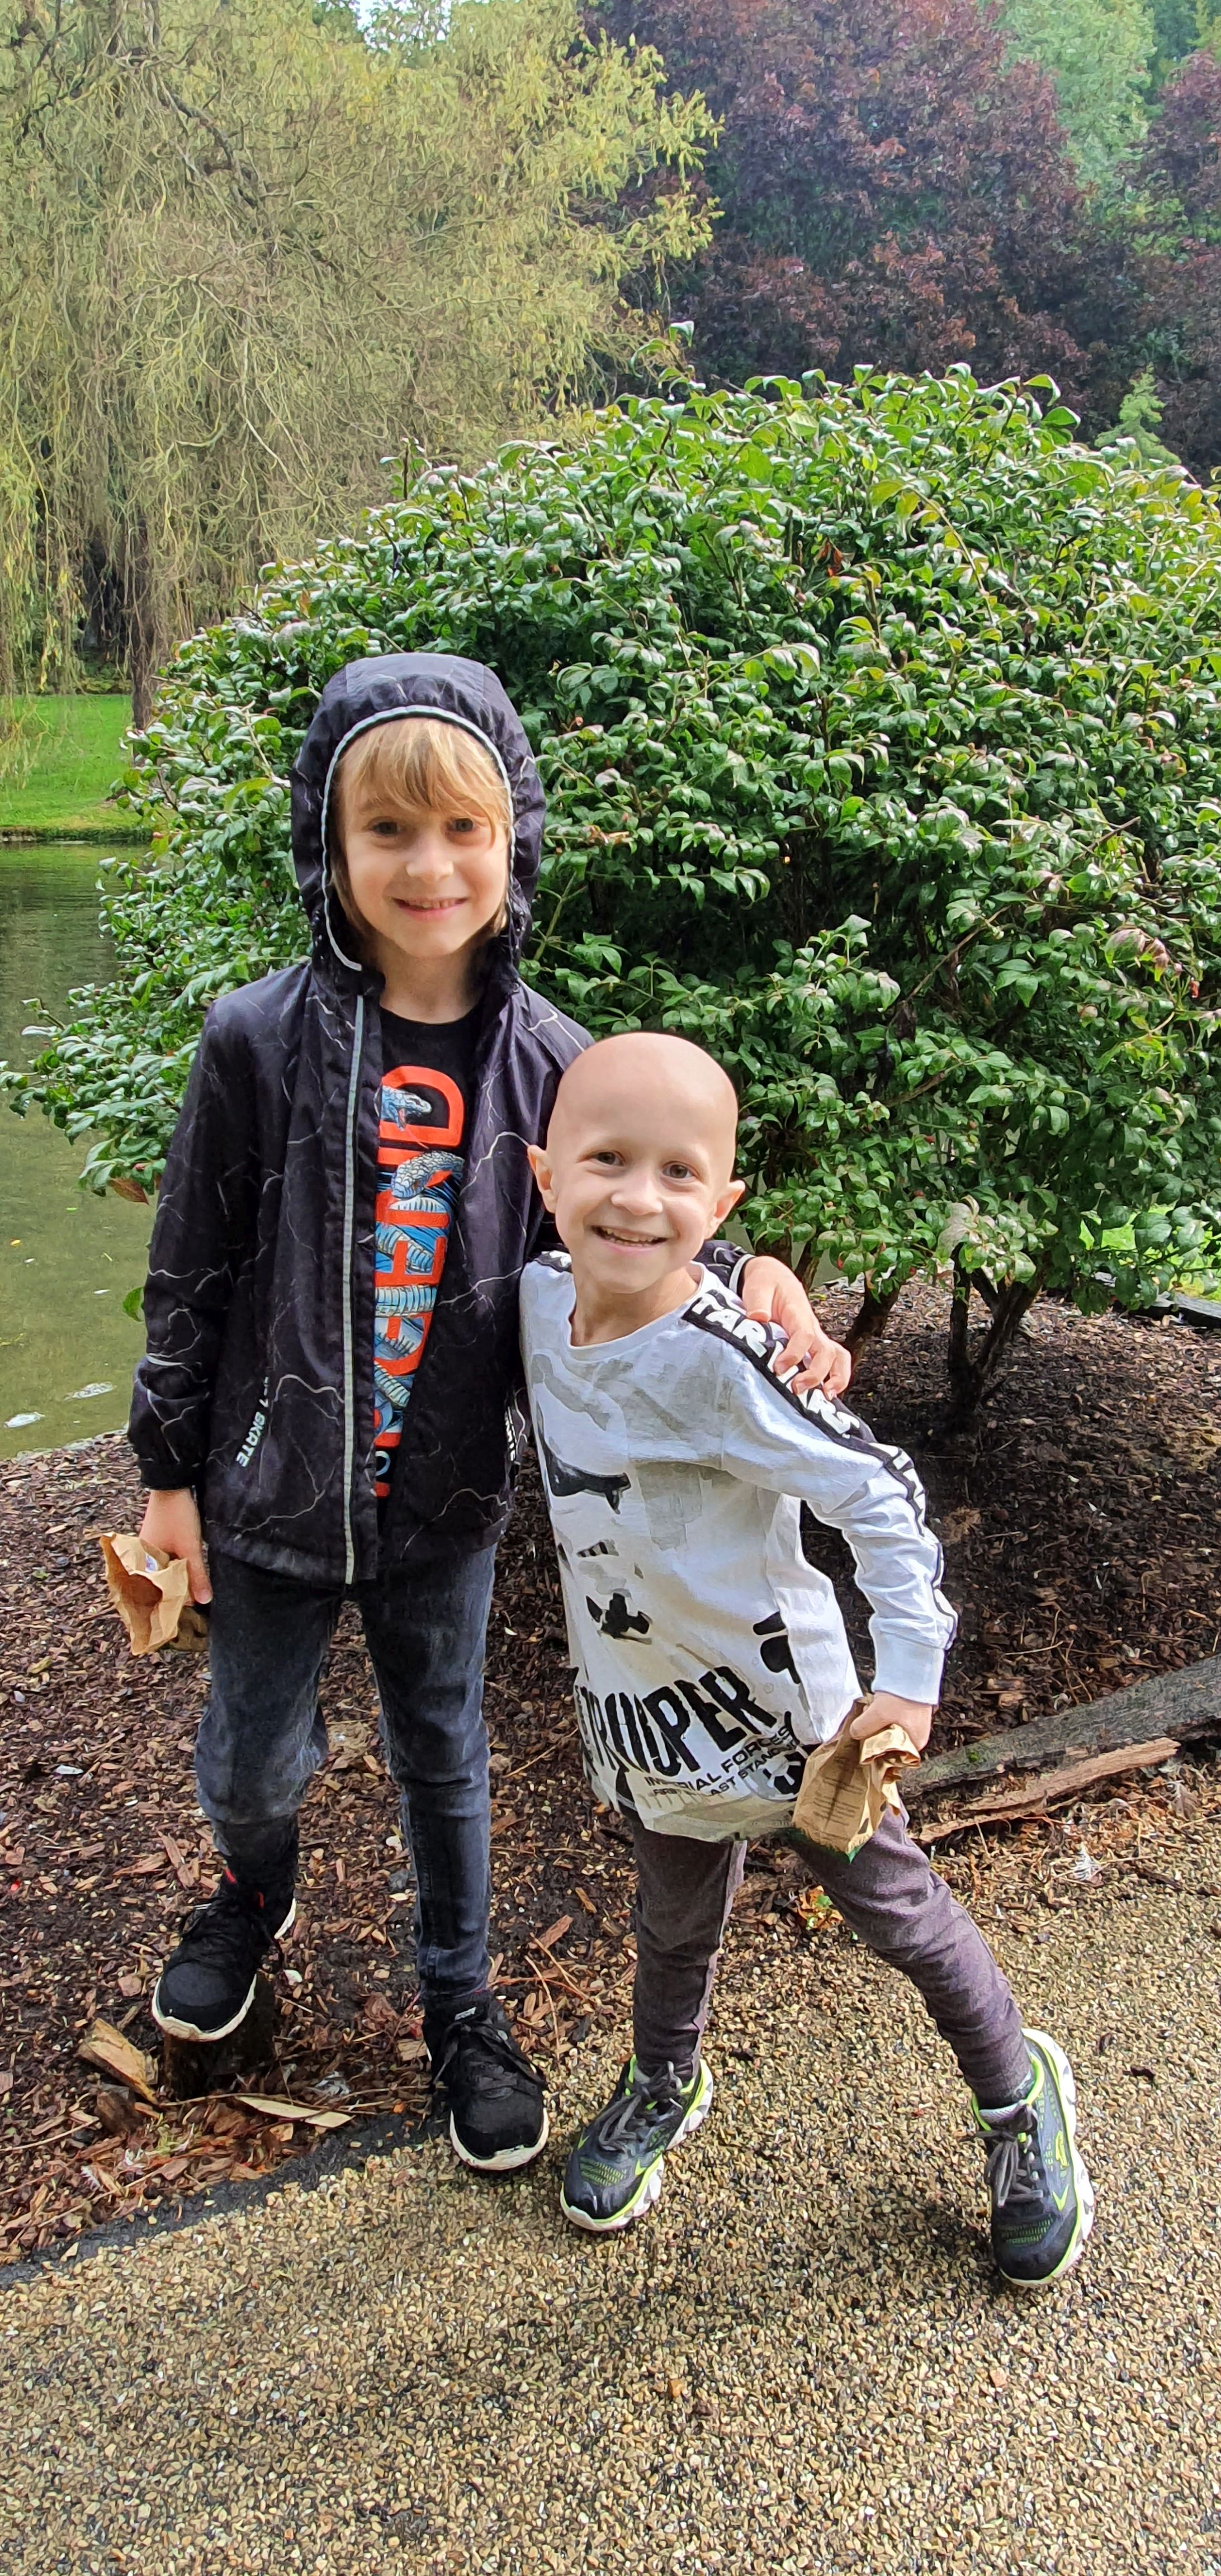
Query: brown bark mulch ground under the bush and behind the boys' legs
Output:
[[0, 1288, 1221, 2262]]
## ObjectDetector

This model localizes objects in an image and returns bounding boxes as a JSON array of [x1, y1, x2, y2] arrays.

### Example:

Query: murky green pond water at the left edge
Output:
[[0, 842, 152, 1458]]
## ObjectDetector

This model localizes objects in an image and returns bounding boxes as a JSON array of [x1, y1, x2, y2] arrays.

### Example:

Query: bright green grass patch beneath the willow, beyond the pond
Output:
[[0, 695, 144, 840]]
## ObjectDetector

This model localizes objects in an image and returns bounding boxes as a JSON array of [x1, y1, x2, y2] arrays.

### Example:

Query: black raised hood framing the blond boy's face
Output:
[[291, 652, 546, 971]]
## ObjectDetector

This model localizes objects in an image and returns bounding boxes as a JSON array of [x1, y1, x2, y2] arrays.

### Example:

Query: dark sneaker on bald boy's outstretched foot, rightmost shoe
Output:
[[974, 2030, 1095, 2290]]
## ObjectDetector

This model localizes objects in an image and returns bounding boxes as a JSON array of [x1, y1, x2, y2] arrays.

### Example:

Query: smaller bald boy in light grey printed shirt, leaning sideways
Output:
[[520, 1033, 1092, 2288]]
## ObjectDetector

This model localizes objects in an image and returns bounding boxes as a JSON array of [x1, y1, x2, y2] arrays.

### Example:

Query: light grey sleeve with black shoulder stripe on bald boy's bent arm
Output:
[[721, 1334, 958, 1700]]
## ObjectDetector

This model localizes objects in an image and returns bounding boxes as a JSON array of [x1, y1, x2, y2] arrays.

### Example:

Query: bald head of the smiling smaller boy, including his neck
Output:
[[531, 1033, 745, 1339]]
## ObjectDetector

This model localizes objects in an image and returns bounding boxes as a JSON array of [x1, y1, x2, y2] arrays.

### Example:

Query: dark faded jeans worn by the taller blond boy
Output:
[[196, 1548, 495, 2012]]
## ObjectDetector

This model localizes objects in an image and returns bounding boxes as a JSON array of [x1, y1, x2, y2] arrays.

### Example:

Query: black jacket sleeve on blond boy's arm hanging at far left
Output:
[[126, 1002, 258, 1489]]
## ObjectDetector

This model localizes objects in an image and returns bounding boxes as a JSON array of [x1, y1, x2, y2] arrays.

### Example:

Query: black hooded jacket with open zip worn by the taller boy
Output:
[[129, 654, 588, 1584]]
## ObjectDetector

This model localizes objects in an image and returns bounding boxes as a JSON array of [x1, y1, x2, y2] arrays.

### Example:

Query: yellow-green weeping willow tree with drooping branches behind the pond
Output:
[[0, 0, 711, 724]]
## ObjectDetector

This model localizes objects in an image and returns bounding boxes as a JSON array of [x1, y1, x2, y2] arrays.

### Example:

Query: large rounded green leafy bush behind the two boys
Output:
[[4, 371, 1221, 1401]]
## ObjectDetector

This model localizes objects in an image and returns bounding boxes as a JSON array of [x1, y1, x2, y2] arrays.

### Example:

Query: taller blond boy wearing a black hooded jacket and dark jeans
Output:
[[129, 654, 848, 2172]]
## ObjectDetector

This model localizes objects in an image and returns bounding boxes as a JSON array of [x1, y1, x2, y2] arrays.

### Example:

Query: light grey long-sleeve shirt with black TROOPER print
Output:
[[520, 1254, 955, 1842]]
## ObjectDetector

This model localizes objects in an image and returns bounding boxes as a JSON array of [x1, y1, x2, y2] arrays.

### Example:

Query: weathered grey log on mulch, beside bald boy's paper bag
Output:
[[904, 1654, 1221, 1806]]
